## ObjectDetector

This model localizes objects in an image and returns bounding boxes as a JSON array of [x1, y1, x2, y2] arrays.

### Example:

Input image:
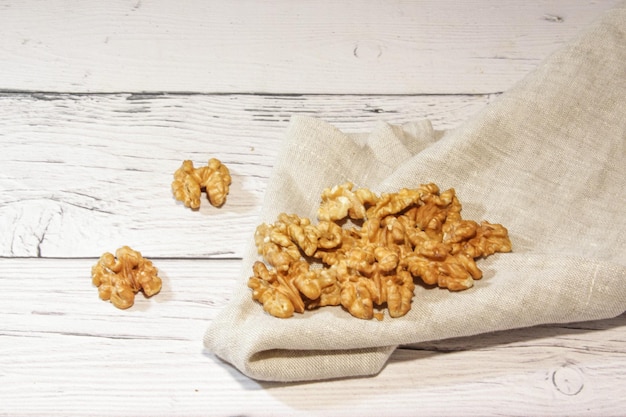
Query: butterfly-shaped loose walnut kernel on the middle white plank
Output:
[[172, 158, 232, 210]]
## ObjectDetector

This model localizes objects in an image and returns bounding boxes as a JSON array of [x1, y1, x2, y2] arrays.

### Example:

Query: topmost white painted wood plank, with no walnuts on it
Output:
[[0, 0, 619, 94]]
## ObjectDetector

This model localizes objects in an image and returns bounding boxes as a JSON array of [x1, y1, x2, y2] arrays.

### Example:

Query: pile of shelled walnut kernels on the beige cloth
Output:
[[248, 183, 511, 320]]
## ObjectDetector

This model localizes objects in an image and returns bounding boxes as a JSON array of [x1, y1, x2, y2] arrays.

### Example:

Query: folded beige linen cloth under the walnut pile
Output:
[[204, 4, 626, 381]]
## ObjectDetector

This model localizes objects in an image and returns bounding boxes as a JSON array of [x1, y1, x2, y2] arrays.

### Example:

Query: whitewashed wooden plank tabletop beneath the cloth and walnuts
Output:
[[0, 0, 626, 416]]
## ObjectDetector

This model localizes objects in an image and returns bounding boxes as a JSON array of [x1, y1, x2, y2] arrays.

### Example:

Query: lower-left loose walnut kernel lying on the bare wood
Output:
[[91, 246, 162, 309]]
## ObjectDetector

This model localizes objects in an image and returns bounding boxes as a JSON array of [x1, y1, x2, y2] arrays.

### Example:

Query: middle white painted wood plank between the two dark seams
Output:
[[0, 94, 489, 258]]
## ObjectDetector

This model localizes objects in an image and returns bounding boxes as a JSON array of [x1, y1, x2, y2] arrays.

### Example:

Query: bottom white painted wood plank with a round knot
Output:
[[0, 259, 626, 416]]
